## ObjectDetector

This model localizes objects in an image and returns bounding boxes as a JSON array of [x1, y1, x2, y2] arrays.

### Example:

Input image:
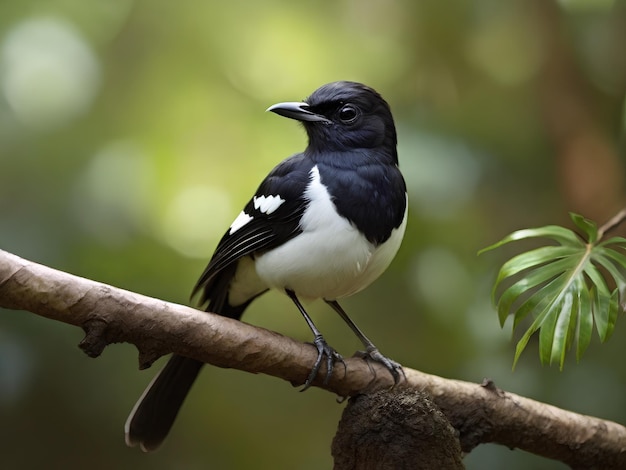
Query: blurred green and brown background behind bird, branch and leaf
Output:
[[0, 0, 626, 470]]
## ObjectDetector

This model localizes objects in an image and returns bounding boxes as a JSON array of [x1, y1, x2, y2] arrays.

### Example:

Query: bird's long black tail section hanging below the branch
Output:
[[124, 355, 204, 452]]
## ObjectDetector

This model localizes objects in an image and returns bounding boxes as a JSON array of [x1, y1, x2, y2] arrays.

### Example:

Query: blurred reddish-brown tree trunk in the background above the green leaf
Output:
[[530, 0, 624, 222]]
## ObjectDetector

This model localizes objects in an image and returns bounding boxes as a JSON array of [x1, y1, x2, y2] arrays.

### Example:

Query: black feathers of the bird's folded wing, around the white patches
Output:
[[192, 154, 313, 313]]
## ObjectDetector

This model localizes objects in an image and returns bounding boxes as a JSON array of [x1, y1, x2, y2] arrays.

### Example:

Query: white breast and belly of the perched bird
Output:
[[255, 163, 406, 300]]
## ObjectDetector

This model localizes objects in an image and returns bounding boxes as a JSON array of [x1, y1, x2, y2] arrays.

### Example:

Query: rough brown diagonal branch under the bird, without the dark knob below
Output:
[[0, 250, 626, 469]]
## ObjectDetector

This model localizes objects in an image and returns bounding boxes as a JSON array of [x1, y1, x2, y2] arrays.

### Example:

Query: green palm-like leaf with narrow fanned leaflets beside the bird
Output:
[[481, 214, 626, 368]]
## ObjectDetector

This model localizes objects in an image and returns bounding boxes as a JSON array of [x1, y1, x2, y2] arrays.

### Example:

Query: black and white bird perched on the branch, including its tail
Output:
[[125, 81, 408, 452]]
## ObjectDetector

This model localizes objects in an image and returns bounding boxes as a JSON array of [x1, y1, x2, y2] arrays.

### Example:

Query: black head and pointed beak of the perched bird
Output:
[[268, 81, 397, 163]]
